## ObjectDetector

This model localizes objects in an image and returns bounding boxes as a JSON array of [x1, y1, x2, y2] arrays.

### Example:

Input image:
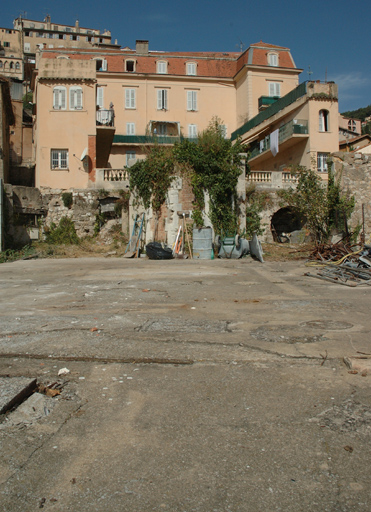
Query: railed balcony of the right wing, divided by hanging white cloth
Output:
[[249, 119, 309, 163]]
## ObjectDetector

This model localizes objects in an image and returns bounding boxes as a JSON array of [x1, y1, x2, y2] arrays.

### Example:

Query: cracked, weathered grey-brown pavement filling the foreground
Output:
[[0, 258, 371, 512]]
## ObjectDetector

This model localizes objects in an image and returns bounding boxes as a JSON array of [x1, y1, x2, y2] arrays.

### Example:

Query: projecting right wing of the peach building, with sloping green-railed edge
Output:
[[237, 82, 339, 180]]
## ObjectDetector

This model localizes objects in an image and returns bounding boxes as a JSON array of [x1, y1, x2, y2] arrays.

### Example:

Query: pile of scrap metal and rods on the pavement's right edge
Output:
[[304, 239, 371, 287]]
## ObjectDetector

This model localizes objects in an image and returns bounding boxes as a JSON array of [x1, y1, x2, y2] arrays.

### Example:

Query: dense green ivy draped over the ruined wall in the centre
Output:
[[130, 118, 244, 233]]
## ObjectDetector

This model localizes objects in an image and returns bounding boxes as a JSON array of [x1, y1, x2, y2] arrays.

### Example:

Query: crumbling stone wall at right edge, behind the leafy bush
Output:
[[332, 152, 371, 240]]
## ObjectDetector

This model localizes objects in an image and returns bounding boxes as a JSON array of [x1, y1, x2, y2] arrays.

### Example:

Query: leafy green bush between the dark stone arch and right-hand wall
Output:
[[278, 163, 355, 243]]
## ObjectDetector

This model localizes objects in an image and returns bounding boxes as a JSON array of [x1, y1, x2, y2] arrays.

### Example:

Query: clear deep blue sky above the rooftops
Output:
[[0, 0, 371, 112]]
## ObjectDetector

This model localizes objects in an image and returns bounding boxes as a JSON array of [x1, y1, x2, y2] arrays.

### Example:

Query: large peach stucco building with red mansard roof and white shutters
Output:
[[33, 41, 339, 189]]
